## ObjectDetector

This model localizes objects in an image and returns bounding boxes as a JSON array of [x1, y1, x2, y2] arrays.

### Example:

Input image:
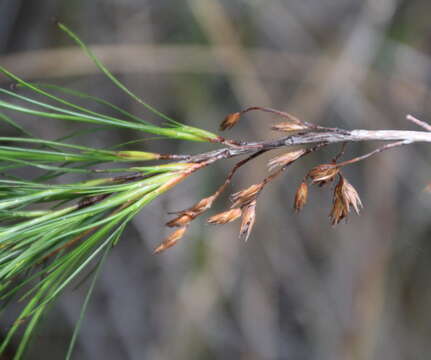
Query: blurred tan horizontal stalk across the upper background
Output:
[[0, 44, 314, 81]]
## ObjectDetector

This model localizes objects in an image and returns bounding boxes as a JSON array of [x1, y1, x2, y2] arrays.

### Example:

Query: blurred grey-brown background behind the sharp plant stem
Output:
[[0, 0, 431, 360]]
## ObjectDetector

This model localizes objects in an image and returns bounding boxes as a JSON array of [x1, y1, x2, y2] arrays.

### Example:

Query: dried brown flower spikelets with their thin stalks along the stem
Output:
[[149, 107, 412, 253]]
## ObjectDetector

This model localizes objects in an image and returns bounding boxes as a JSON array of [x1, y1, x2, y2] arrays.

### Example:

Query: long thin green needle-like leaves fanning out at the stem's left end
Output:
[[0, 24, 217, 359]]
